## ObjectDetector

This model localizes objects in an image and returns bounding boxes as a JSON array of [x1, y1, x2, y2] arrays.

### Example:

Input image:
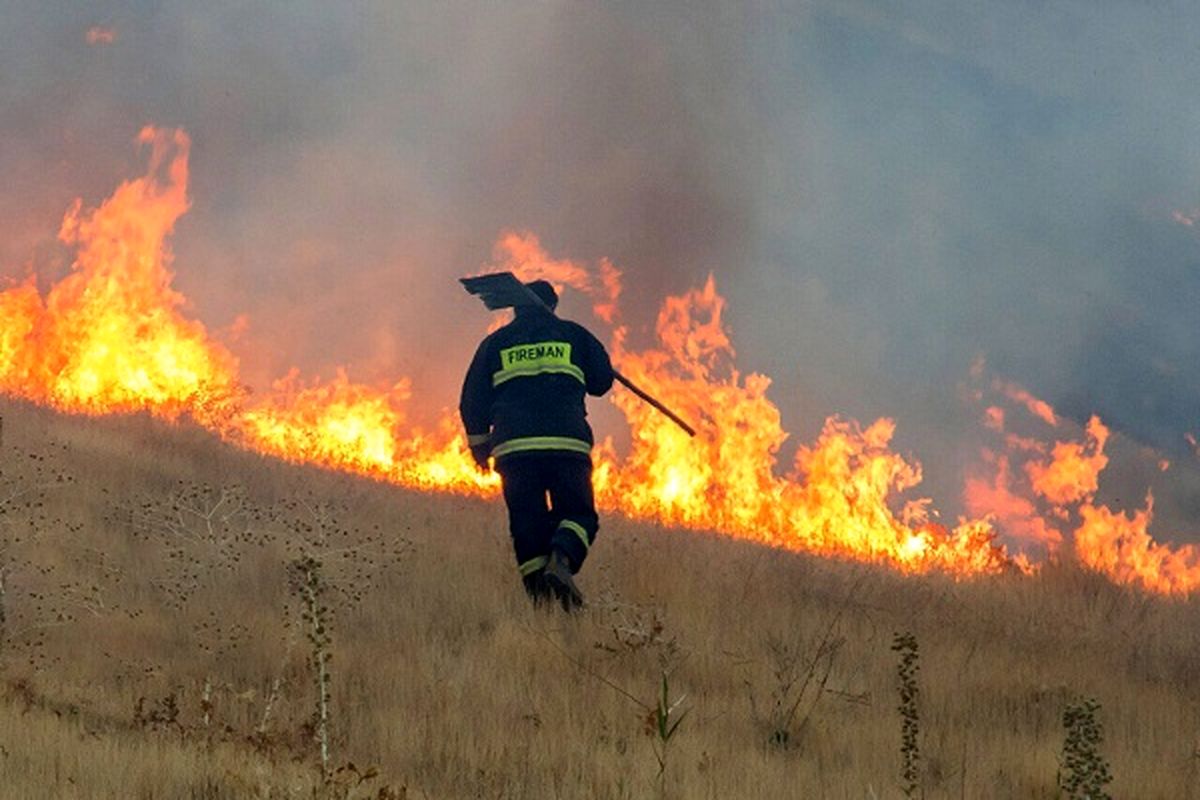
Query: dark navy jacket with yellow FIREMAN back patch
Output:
[[458, 308, 613, 462]]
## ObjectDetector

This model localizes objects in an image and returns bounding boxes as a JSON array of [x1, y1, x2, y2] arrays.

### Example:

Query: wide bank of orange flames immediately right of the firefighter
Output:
[[585, 276, 1007, 575]]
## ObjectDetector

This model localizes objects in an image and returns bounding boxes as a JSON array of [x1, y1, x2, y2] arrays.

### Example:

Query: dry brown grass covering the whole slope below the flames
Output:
[[0, 402, 1200, 799]]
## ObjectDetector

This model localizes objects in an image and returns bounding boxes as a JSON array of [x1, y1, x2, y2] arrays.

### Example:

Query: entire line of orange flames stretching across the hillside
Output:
[[0, 128, 1200, 594]]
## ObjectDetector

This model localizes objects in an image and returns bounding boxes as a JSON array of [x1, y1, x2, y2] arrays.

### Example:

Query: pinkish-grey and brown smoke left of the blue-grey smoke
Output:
[[2, 1, 760, 389]]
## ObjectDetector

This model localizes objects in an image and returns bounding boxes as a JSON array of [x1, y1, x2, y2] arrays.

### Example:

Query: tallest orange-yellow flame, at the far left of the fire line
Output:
[[0, 127, 240, 423]]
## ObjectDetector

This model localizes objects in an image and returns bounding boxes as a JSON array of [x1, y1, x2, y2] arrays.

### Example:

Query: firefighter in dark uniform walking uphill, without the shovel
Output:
[[458, 281, 613, 610]]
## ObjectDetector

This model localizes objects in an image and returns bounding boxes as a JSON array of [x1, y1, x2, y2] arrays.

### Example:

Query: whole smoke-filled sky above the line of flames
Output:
[[0, 0, 1200, 528]]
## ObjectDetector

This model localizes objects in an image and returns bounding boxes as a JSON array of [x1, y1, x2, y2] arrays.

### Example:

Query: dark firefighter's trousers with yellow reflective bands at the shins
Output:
[[496, 453, 600, 578]]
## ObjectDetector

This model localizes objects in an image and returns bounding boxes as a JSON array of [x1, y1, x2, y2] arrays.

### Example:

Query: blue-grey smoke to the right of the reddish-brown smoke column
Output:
[[731, 1, 1200, 525]]
